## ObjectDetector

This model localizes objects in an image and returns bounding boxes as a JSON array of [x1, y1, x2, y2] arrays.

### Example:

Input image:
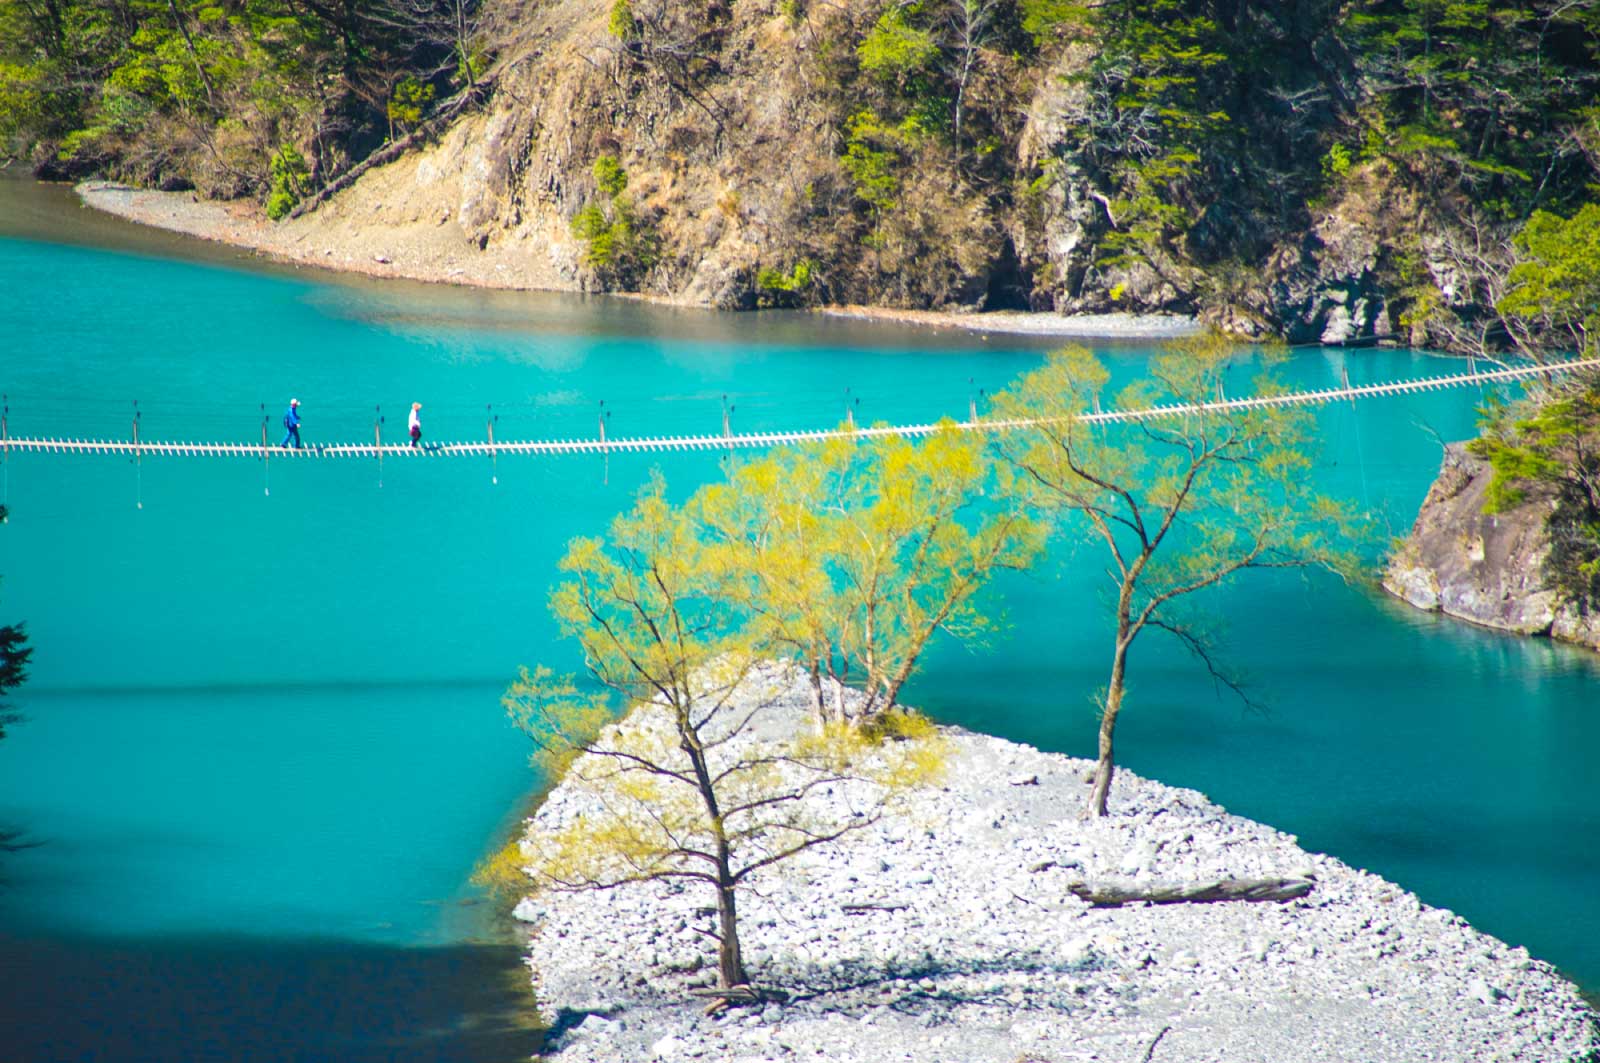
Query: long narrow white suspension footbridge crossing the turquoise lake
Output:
[[3, 359, 1600, 458]]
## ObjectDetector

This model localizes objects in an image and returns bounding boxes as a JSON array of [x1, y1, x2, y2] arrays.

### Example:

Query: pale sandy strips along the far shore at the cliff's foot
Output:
[[77, 181, 1197, 341]]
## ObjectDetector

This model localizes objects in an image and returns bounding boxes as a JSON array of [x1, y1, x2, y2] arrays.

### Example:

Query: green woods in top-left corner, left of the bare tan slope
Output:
[[0, 0, 485, 205]]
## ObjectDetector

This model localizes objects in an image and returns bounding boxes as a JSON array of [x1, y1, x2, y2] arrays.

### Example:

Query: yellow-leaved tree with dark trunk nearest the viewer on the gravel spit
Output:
[[506, 475, 939, 1009]]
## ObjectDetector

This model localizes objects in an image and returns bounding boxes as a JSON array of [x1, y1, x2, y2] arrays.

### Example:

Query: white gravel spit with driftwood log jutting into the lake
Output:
[[517, 669, 1600, 1063]]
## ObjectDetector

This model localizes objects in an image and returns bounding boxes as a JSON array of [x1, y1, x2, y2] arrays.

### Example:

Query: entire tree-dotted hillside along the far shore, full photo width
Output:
[[0, 0, 1600, 342]]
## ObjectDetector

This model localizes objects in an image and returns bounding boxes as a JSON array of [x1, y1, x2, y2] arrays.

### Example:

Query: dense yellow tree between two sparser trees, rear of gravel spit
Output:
[[691, 423, 1042, 724]]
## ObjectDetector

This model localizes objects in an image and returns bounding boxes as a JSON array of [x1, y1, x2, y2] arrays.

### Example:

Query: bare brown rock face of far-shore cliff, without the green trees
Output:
[[272, 0, 1452, 328]]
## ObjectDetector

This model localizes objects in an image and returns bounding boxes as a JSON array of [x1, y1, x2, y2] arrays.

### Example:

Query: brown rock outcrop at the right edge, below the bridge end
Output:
[[1384, 443, 1600, 650]]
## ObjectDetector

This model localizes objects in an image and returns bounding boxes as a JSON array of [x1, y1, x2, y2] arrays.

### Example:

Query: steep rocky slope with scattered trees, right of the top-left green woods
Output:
[[268, 0, 1600, 346]]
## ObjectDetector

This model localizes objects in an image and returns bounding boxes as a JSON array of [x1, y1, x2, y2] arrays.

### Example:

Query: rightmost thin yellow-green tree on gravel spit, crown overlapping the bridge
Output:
[[994, 333, 1354, 816]]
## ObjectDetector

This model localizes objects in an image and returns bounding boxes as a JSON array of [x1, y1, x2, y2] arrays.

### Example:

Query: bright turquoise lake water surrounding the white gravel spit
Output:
[[0, 183, 1600, 1060]]
